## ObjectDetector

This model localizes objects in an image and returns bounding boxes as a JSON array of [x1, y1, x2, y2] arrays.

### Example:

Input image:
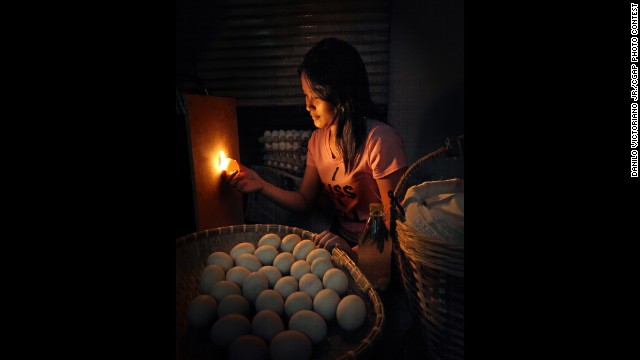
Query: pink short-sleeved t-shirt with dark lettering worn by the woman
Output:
[[307, 120, 407, 245]]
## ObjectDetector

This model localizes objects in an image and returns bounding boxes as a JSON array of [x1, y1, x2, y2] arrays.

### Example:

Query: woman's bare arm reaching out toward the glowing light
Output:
[[230, 165, 322, 212]]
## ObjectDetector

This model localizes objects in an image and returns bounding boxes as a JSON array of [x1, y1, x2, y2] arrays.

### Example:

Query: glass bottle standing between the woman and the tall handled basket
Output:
[[358, 203, 391, 291]]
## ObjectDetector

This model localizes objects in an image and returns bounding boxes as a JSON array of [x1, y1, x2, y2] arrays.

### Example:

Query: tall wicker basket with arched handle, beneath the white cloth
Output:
[[392, 142, 464, 359]]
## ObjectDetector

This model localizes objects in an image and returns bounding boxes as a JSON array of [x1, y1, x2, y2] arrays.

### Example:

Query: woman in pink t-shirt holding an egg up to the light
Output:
[[230, 38, 407, 261]]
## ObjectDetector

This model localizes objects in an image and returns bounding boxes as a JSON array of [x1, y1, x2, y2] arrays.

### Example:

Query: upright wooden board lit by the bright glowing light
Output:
[[185, 94, 244, 231]]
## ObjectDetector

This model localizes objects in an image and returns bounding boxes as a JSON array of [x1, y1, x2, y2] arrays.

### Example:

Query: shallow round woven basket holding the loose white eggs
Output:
[[176, 224, 384, 360]]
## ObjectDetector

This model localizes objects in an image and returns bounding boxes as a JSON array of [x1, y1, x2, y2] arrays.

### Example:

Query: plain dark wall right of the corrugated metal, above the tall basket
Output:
[[389, 0, 464, 162]]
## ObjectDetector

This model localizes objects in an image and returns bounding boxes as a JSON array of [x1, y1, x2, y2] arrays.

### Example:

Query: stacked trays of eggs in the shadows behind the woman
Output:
[[258, 130, 311, 176]]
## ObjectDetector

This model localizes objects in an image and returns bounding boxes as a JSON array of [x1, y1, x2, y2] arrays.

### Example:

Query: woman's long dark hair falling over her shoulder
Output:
[[298, 38, 385, 173]]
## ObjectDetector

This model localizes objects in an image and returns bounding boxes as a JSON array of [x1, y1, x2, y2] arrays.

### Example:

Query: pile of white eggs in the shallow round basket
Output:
[[187, 233, 366, 360]]
